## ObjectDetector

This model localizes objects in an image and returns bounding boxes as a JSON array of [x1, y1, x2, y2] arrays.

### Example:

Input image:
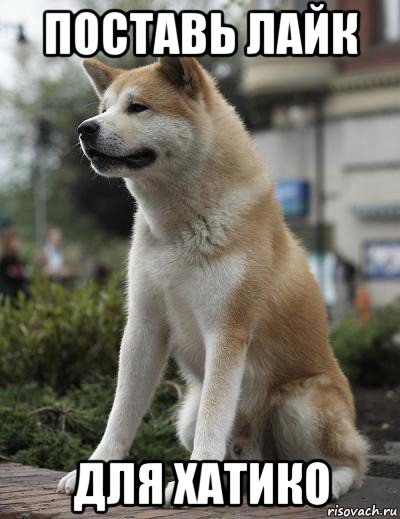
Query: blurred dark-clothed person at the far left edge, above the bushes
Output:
[[0, 229, 28, 298]]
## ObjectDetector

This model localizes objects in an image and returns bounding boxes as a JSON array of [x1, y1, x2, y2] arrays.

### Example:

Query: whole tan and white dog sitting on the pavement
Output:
[[59, 57, 367, 500]]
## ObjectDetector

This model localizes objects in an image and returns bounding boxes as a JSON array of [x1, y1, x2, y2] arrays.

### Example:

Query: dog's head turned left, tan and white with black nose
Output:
[[78, 57, 214, 178]]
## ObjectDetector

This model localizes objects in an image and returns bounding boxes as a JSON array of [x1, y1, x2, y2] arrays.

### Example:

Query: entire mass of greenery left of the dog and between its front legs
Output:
[[0, 277, 185, 470]]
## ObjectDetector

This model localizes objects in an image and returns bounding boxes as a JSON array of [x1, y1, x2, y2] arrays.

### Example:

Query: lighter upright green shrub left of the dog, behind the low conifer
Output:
[[0, 277, 124, 393]]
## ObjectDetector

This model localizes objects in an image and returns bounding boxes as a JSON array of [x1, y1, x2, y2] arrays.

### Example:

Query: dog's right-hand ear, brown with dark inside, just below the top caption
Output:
[[159, 56, 204, 98]]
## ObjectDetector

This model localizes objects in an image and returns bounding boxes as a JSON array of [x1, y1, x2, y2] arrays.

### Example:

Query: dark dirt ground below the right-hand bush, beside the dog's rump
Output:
[[353, 387, 400, 446]]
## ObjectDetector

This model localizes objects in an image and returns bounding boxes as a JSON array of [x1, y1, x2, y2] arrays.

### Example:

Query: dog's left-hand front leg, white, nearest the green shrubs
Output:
[[58, 279, 168, 494]]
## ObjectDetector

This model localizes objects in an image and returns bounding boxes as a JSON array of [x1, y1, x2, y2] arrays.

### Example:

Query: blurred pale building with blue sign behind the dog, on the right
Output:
[[243, 0, 400, 312]]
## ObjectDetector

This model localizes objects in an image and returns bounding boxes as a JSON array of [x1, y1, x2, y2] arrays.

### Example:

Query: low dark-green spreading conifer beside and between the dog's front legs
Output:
[[0, 379, 186, 471]]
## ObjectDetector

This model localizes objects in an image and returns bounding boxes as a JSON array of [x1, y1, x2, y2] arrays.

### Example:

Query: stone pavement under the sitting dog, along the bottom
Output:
[[0, 463, 400, 519]]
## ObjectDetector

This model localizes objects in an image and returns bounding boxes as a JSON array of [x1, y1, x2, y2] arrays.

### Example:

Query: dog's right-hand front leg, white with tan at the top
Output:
[[191, 332, 247, 461]]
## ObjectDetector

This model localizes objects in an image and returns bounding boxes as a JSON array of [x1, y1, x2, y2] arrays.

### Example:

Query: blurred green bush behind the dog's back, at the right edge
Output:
[[331, 300, 400, 386]]
